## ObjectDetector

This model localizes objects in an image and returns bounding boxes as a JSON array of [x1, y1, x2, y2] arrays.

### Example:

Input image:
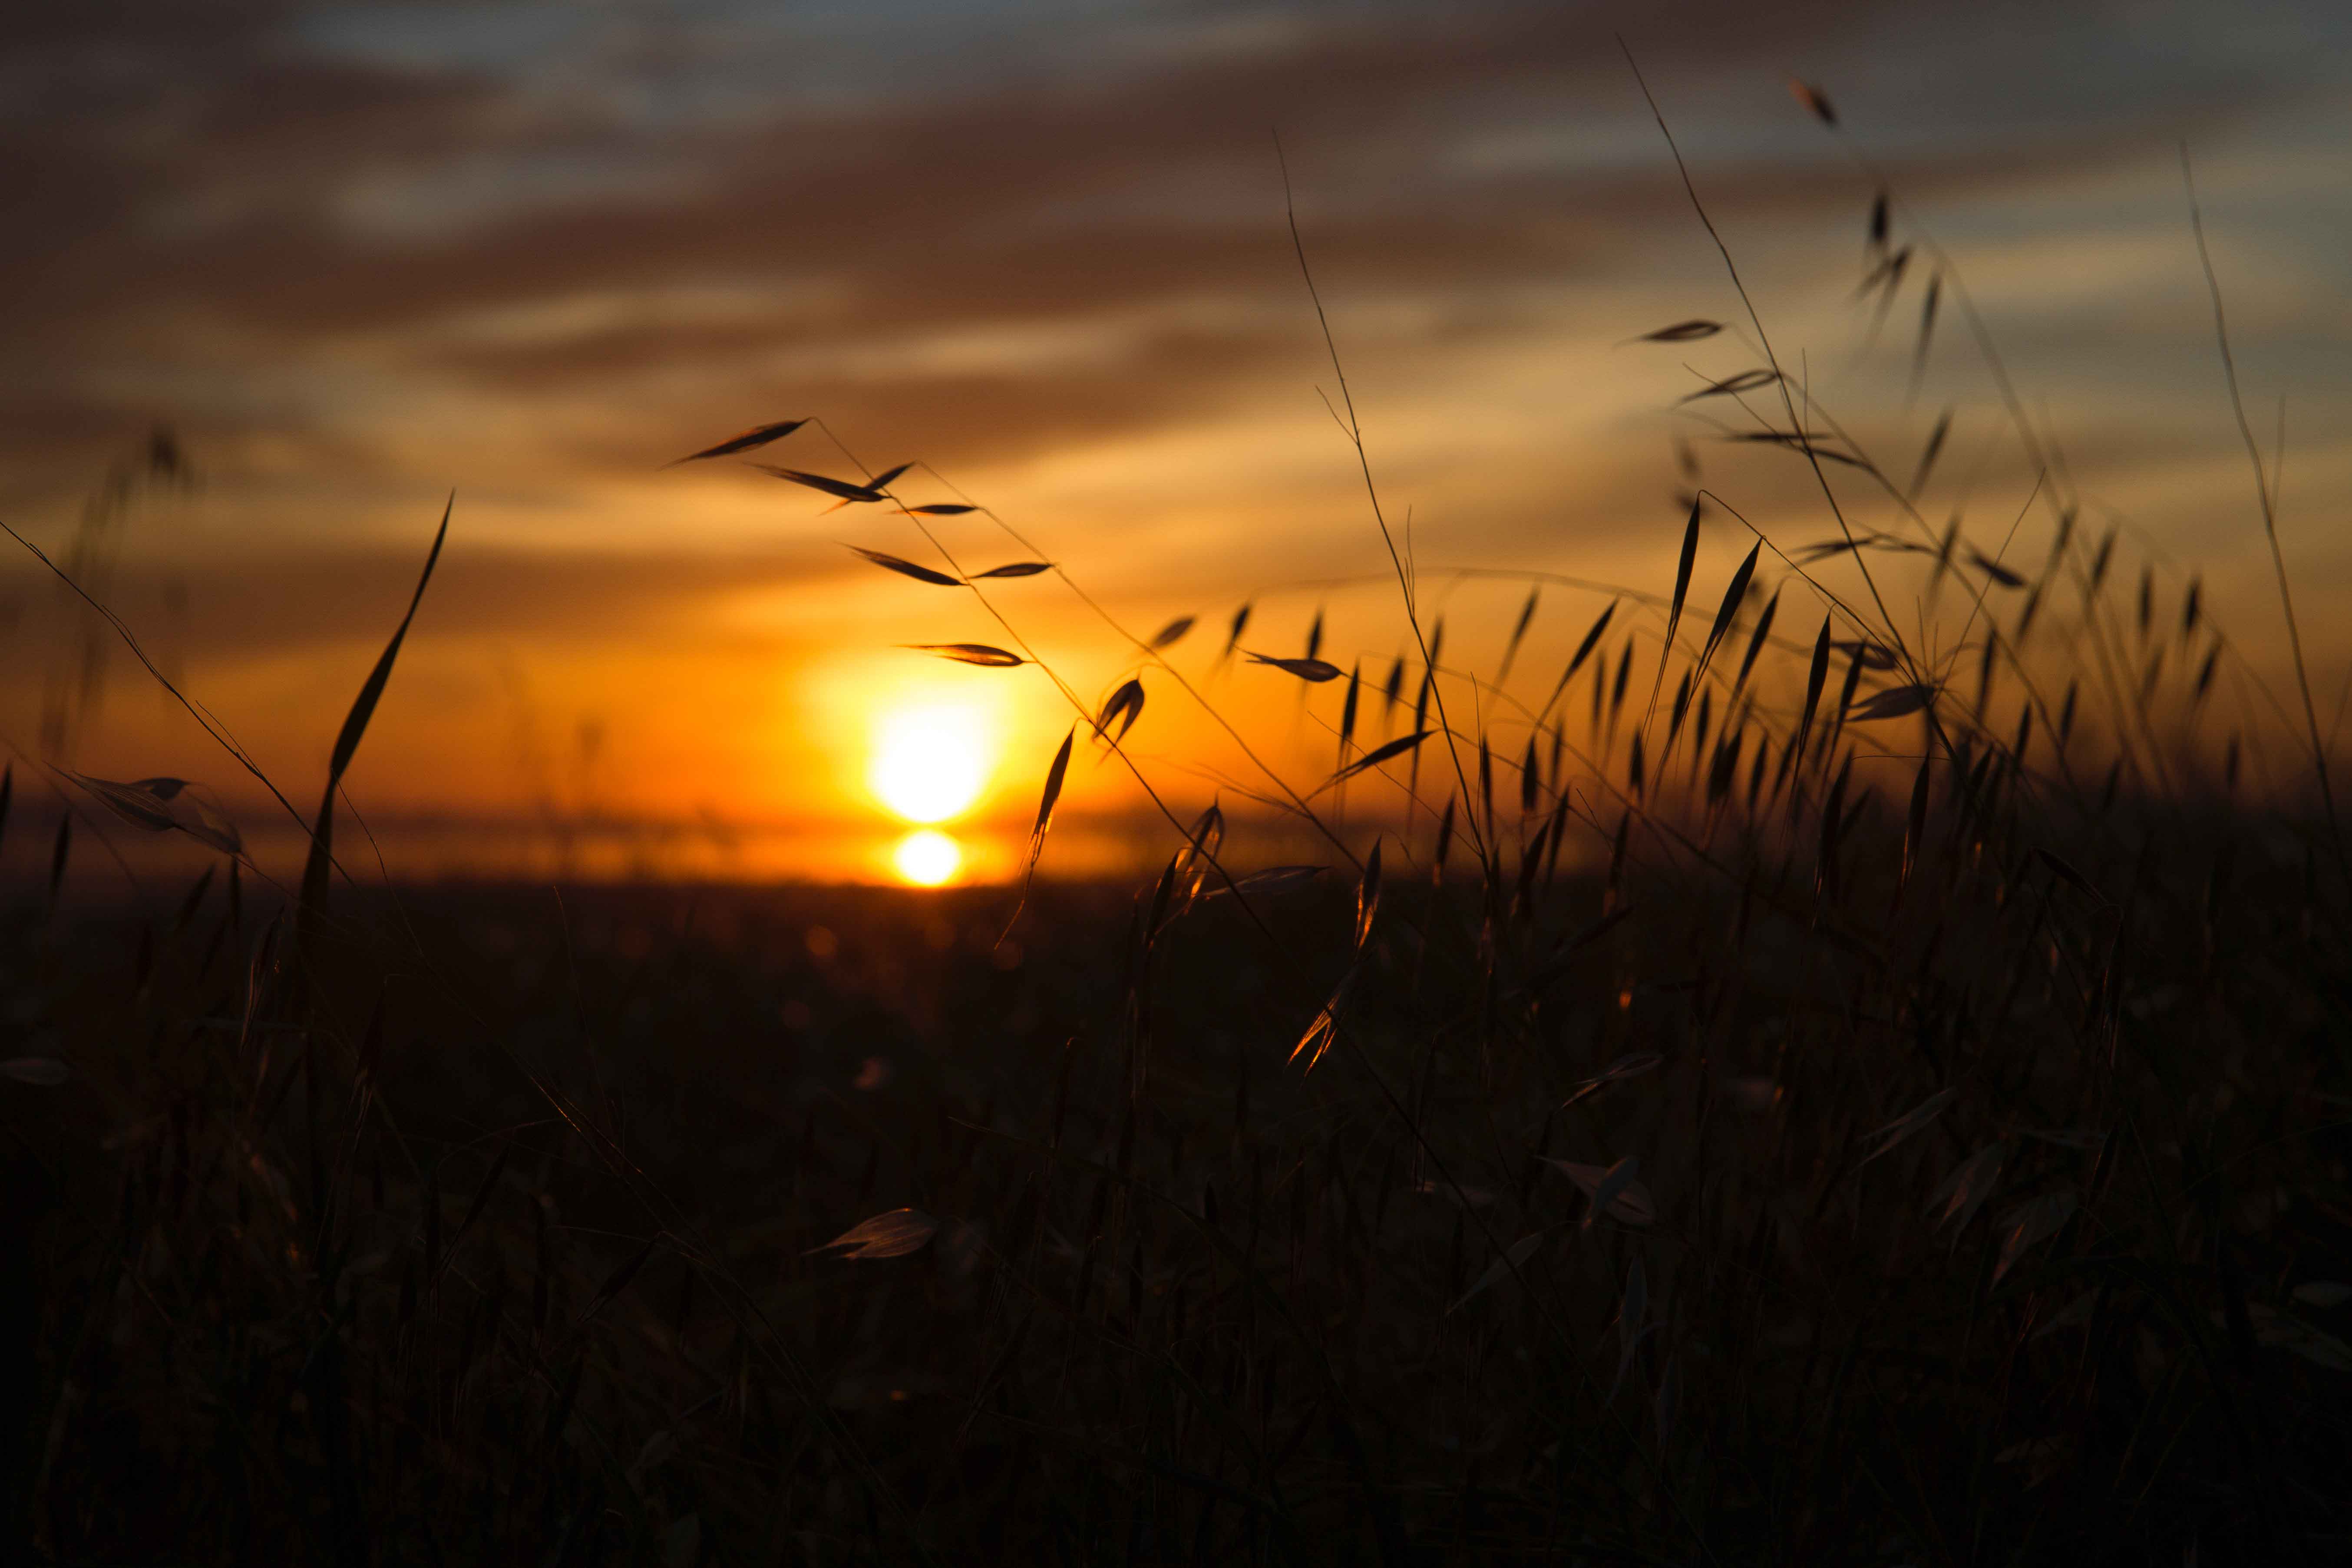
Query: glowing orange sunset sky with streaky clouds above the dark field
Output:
[[0, 0, 2352, 877]]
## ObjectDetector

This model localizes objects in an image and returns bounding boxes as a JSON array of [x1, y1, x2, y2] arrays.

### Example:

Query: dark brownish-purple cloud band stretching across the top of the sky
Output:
[[0, 0, 2296, 493]]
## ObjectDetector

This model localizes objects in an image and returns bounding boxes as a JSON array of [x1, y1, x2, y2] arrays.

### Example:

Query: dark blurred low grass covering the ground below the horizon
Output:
[[18, 790, 2352, 1563]]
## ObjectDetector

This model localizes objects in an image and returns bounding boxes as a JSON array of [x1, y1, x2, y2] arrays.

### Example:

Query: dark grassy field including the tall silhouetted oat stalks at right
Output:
[[0, 113, 2352, 1568]]
